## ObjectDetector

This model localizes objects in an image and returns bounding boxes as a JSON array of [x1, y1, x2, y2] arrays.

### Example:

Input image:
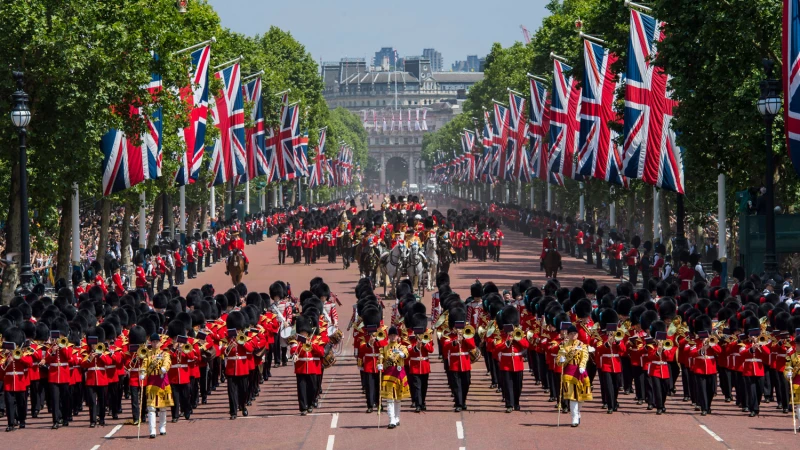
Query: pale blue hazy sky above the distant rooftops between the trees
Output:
[[208, 0, 547, 70]]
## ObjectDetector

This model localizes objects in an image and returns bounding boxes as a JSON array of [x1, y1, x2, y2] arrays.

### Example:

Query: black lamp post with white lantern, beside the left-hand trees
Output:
[[11, 71, 33, 289]]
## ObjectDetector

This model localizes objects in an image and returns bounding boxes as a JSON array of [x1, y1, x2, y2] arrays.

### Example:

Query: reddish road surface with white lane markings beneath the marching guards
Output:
[[7, 206, 800, 450]]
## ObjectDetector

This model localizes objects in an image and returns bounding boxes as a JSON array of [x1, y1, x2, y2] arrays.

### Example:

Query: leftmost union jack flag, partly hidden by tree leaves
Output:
[[100, 53, 163, 196]]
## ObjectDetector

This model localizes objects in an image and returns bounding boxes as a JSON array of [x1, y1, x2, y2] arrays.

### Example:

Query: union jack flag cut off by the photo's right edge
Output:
[[782, 0, 800, 175]]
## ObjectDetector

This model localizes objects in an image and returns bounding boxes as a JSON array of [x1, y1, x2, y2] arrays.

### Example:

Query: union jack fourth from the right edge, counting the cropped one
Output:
[[549, 59, 582, 180]]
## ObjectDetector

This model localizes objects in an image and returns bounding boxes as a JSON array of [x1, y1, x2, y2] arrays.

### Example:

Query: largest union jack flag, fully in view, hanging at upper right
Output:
[[624, 10, 683, 194]]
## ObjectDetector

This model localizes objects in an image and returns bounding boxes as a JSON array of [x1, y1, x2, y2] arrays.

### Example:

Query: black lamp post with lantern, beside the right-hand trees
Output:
[[758, 59, 781, 280]]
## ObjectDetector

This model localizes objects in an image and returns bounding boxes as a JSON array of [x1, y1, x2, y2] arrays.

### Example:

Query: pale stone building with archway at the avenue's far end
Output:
[[322, 58, 483, 189]]
